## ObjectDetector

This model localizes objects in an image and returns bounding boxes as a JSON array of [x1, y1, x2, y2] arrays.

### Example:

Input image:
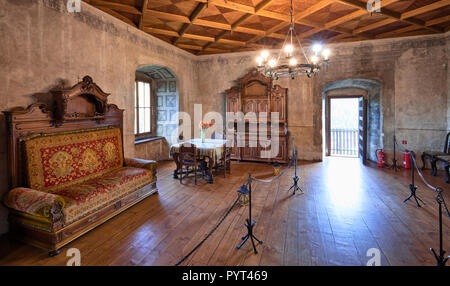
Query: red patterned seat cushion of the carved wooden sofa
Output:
[[52, 167, 155, 225]]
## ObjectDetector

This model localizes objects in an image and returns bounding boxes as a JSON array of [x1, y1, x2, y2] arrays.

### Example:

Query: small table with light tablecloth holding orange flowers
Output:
[[170, 138, 227, 184]]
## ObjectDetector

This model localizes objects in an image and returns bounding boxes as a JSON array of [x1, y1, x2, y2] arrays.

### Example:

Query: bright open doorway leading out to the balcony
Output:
[[325, 95, 367, 163]]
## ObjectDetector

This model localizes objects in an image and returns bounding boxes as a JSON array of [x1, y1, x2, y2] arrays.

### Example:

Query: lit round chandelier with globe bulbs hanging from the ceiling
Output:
[[256, 0, 330, 79]]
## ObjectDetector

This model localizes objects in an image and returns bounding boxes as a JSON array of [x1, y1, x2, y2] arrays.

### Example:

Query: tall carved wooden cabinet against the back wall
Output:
[[226, 70, 289, 163]]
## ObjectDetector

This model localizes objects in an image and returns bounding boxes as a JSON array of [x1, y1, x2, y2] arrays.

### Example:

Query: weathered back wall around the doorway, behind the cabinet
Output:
[[197, 33, 450, 162]]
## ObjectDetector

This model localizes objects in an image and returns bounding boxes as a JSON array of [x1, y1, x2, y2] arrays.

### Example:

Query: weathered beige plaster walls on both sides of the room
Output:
[[0, 0, 450, 236]]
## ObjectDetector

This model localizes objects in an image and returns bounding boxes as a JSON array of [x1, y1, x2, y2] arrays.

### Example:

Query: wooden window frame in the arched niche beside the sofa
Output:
[[134, 76, 157, 140]]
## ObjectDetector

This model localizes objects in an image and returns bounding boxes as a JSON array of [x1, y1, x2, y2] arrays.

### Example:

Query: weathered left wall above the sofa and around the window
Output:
[[0, 0, 197, 233]]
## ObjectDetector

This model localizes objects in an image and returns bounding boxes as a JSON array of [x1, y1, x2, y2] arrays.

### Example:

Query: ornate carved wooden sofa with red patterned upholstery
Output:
[[3, 76, 157, 255]]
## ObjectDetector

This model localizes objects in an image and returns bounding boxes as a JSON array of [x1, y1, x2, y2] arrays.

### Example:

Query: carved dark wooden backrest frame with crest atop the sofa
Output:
[[3, 76, 123, 188]]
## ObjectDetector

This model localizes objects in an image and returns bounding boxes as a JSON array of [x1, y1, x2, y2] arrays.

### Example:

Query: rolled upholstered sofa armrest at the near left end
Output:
[[3, 188, 65, 218]]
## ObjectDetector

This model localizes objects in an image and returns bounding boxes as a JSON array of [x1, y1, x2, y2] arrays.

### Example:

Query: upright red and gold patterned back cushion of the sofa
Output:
[[23, 127, 123, 191]]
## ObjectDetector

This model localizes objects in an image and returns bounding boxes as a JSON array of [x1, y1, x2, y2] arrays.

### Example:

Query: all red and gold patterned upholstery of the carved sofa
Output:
[[5, 127, 156, 230]]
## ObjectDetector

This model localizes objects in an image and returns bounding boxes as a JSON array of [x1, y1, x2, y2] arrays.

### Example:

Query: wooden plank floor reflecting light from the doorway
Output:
[[0, 158, 450, 265]]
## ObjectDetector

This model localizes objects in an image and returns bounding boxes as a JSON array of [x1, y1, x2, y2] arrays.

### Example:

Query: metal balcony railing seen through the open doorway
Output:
[[330, 129, 358, 157]]
